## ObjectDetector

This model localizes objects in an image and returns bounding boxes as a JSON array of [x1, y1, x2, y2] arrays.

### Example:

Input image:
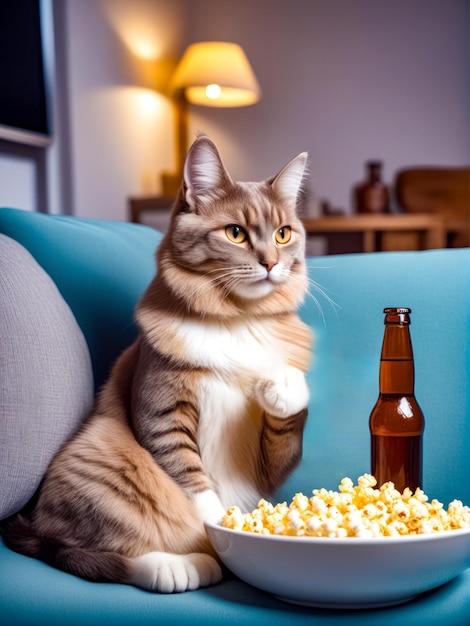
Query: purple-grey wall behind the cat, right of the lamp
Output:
[[185, 0, 470, 209]]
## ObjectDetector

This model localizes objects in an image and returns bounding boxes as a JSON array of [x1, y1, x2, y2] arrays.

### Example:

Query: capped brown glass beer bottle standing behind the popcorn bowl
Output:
[[369, 308, 424, 491]]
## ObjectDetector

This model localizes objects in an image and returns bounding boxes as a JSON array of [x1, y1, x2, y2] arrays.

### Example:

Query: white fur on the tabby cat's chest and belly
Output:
[[173, 314, 302, 510]]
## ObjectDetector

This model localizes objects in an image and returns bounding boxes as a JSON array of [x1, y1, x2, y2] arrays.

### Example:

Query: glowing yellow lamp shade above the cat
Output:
[[171, 41, 261, 107]]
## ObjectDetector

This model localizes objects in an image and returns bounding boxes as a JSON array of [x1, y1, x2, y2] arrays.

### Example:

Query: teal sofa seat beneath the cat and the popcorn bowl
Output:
[[0, 540, 470, 626]]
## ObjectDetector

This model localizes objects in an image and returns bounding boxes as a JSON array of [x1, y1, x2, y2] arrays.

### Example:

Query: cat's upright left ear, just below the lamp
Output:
[[184, 135, 232, 208]]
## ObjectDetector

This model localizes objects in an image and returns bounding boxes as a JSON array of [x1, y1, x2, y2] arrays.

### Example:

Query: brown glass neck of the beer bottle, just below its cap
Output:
[[379, 324, 414, 396]]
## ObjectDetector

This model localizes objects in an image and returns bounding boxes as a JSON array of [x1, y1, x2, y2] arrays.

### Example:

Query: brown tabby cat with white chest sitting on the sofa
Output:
[[4, 135, 312, 593]]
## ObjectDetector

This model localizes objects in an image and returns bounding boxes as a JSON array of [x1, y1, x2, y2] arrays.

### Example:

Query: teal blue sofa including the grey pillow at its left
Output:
[[0, 209, 470, 626]]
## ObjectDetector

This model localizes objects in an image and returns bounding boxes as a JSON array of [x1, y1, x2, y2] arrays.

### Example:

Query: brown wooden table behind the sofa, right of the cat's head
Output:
[[302, 213, 446, 254]]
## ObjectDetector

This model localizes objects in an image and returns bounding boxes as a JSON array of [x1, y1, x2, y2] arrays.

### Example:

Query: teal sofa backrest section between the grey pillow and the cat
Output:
[[0, 209, 162, 388]]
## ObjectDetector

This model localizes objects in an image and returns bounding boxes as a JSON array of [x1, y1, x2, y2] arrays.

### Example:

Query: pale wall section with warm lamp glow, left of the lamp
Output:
[[66, 0, 184, 220]]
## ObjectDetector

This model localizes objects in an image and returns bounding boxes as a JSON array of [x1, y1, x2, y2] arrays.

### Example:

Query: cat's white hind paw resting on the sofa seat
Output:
[[129, 552, 222, 593]]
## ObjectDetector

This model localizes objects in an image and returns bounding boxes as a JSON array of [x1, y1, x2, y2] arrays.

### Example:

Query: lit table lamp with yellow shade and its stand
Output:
[[162, 41, 261, 196]]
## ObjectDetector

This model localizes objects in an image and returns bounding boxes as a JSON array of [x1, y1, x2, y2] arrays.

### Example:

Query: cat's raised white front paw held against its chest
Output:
[[255, 365, 309, 418]]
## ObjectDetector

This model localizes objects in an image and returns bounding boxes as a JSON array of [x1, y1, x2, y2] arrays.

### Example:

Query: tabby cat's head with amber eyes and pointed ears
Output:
[[158, 135, 307, 316]]
